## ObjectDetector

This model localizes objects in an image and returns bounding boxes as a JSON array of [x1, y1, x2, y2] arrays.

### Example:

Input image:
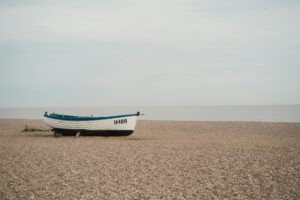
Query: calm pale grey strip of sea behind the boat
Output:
[[0, 105, 300, 122]]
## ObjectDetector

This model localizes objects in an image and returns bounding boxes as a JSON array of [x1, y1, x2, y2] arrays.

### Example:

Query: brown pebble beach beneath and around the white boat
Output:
[[0, 119, 300, 199]]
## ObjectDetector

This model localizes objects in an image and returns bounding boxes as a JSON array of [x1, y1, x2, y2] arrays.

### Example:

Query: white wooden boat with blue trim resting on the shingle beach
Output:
[[44, 112, 140, 136]]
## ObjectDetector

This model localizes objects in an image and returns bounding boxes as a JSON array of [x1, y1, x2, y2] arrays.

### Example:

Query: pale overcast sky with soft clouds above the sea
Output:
[[0, 0, 300, 107]]
